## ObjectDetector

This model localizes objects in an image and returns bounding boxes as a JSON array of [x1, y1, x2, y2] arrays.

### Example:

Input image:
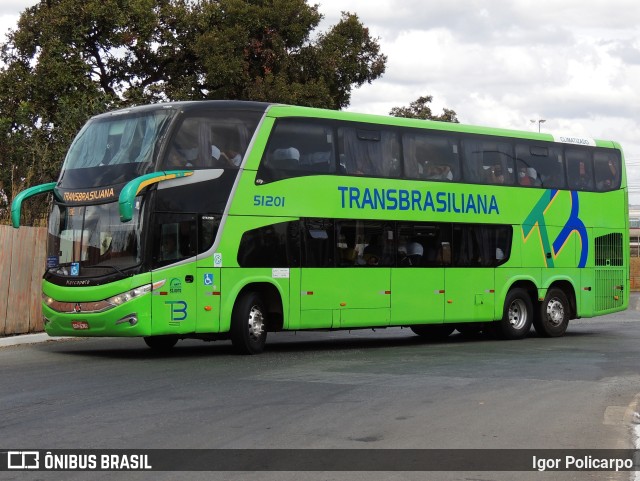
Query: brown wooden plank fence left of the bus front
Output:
[[0, 225, 47, 336]]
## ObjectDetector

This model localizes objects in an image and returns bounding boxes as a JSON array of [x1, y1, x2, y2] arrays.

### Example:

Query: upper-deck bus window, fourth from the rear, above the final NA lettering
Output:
[[462, 140, 515, 185]]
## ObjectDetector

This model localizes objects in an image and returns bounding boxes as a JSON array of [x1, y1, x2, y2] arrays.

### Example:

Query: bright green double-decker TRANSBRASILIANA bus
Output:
[[12, 101, 629, 353]]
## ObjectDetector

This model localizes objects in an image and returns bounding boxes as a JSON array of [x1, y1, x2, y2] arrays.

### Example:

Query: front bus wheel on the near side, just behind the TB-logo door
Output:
[[231, 292, 267, 354]]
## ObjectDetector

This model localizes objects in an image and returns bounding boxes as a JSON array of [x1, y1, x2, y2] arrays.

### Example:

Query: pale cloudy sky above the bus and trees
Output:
[[0, 0, 640, 204]]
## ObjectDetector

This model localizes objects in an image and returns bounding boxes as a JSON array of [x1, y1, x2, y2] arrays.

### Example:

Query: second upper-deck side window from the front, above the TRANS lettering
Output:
[[338, 127, 401, 177]]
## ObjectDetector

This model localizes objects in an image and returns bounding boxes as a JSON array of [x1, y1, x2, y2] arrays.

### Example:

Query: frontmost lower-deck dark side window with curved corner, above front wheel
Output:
[[238, 222, 300, 267]]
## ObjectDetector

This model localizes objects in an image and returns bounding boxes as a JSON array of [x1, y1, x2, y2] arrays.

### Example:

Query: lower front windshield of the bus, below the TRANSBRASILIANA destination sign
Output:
[[47, 199, 142, 277]]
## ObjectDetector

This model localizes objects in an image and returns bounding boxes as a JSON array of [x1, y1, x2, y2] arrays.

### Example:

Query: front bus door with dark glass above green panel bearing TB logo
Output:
[[151, 213, 198, 335]]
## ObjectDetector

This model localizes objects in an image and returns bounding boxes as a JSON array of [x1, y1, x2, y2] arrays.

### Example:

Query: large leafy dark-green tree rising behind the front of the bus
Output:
[[0, 0, 386, 221]]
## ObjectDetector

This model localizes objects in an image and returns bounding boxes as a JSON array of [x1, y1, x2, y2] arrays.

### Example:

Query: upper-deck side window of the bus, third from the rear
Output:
[[516, 144, 566, 189]]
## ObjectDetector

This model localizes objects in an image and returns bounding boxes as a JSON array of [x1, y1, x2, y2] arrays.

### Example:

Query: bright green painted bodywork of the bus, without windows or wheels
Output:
[[37, 106, 629, 336]]
